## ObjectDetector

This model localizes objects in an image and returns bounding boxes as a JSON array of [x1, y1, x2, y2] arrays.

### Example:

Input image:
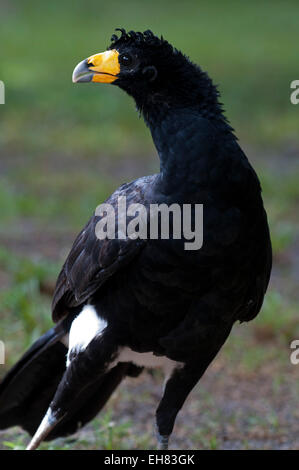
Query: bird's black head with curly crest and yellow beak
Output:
[[73, 29, 223, 123]]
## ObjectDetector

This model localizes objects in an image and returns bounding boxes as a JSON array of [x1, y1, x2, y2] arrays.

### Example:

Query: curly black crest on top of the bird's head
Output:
[[109, 28, 174, 51]]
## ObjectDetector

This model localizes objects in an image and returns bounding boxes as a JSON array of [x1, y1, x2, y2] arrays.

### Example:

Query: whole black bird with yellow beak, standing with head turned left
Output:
[[0, 28, 272, 450]]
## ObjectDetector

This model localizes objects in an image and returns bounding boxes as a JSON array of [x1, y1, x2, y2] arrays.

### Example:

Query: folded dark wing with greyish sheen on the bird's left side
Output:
[[52, 175, 156, 322]]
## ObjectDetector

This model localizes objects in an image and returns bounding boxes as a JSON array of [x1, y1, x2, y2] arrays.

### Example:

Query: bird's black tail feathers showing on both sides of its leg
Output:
[[0, 324, 140, 440]]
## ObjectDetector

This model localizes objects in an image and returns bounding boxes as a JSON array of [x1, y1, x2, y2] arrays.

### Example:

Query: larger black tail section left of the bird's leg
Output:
[[0, 323, 67, 434]]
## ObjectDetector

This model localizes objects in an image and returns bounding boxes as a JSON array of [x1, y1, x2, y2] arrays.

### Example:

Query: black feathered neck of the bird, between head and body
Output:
[[134, 67, 235, 194]]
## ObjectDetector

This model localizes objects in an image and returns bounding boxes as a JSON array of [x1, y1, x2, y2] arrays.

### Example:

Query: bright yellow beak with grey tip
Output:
[[72, 49, 120, 83]]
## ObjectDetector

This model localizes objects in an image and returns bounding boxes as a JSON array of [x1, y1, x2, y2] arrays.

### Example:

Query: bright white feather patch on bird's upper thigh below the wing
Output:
[[66, 305, 107, 367]]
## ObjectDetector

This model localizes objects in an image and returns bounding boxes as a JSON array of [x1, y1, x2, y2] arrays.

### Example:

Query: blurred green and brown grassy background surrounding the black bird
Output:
[[0, 0, 299, 448]]
